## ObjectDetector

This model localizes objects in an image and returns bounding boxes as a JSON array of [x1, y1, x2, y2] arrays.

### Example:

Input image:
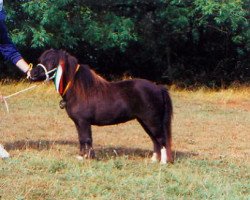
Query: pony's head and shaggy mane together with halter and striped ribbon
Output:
[[30, 49, 108, 98]]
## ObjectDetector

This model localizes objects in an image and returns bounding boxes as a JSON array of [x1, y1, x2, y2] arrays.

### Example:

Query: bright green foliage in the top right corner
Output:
[[194, 0, 250, 54]]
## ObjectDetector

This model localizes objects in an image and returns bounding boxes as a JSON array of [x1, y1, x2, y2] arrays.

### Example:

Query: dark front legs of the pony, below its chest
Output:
[[76, 121, 95, 158]]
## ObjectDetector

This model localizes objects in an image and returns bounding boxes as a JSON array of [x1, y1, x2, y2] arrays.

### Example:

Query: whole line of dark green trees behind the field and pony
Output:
[[0, 0, 250, 87]]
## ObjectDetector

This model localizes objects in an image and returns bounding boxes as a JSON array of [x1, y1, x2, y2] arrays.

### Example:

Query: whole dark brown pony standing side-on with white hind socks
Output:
[[31, 49, 173, 163]]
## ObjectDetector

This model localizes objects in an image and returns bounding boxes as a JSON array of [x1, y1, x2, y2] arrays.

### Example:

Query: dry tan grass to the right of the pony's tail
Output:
[[173, 87, 250, 161]]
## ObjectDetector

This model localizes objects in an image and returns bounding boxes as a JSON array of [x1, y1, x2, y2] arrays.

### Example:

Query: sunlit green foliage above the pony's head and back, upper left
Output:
[[5, 0, 136, 50]]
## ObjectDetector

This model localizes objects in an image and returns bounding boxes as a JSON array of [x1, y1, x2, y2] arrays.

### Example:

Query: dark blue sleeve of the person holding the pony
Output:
[[0, 10, 22, 64]]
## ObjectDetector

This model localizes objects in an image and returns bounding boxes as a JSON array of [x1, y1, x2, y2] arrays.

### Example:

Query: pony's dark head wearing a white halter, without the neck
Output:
[[30, 49, 63, 81]]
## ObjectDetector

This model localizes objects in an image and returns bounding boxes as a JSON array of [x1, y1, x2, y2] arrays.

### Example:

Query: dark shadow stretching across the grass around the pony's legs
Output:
[[4, 140, 198, 160]]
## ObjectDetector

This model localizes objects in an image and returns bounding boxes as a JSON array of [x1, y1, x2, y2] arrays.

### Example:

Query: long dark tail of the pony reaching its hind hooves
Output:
[[162, 87, 173, 163]]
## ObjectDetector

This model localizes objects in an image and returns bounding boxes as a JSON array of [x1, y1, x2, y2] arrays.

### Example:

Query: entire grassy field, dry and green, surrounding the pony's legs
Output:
[[0, 83, 250, 200]]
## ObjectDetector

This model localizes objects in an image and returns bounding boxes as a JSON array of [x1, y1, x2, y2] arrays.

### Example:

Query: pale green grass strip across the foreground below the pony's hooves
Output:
[[0, 152, 250, 199]]
